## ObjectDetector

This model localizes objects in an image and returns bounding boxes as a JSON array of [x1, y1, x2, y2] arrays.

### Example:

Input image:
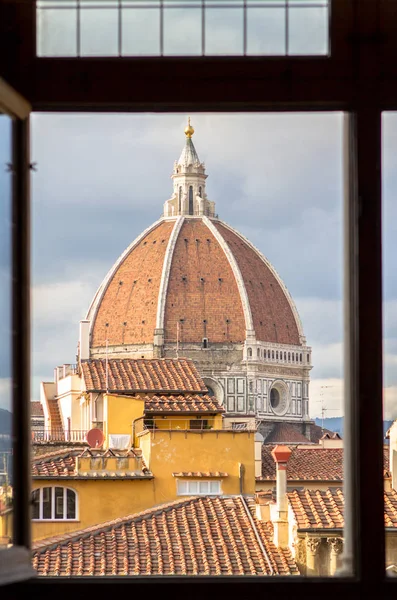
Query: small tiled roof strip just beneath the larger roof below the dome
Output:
[[145, 394, 224, 413]]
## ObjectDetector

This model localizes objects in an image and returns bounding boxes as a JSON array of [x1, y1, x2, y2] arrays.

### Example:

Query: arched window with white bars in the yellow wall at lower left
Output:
[[32, 486, 77, 521]]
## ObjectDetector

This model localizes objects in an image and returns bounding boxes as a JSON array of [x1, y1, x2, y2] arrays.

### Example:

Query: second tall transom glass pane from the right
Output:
[[247, 8, 286, 56]]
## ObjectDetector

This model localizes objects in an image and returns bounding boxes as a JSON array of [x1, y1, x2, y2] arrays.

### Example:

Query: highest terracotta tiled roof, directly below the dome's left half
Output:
[[82, 358, 207, 393]]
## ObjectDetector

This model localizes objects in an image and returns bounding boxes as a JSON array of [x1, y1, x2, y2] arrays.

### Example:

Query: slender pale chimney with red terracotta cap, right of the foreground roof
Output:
[[272, 446, 291, 548]]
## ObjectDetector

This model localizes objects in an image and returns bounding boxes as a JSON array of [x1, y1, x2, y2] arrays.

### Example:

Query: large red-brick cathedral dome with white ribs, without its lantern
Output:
[[87, 216, 304, 349]]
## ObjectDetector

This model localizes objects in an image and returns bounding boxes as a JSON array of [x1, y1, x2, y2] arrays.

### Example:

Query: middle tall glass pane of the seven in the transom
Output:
[[164, 8, 202, 56]]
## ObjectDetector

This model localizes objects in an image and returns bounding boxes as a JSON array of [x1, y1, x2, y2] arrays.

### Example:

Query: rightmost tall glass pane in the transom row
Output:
[[288, 7, 328, 55]]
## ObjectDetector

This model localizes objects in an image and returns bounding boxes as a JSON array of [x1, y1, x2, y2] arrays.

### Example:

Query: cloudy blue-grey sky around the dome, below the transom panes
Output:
[[0, 113, 397, 418]]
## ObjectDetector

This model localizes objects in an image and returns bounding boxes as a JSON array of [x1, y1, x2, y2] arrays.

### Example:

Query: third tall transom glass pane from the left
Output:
[[121, 8, 160, 56]]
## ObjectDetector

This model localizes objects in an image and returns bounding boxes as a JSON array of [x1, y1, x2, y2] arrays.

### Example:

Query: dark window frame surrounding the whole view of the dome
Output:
[[0, 0, 397, 598]]
